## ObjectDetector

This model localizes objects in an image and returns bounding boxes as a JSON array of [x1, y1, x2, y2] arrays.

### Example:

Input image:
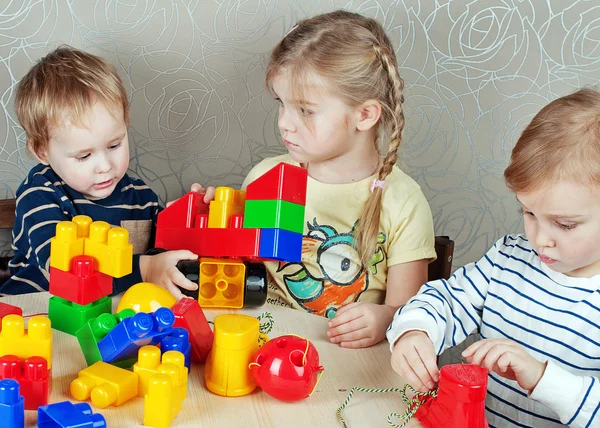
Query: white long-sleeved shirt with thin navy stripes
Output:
[[387, 235, 600, 428]]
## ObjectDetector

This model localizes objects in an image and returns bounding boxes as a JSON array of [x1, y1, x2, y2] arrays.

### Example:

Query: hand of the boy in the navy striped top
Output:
[[140, 250, 198, 300]]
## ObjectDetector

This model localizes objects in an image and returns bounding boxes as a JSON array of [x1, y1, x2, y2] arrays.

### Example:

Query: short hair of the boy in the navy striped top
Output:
[[15, 45, 129, 156]]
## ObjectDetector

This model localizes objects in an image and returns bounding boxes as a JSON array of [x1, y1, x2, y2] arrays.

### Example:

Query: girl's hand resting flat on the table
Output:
[[327, 303, 396, 348]]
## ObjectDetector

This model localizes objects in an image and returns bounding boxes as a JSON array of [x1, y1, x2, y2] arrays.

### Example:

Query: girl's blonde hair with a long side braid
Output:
[[267, 11, 404, 265]]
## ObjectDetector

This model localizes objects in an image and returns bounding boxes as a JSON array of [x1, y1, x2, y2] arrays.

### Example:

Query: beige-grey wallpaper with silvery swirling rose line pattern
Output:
[[0, 0, 600, 266]]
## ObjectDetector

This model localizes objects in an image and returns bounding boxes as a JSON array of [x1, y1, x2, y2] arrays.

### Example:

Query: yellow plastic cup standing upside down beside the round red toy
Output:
[[204, 314, 259, 397]]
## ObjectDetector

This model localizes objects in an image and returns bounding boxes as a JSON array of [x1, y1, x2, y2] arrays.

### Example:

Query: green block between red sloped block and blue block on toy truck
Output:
[[244, 200, 304, 233]]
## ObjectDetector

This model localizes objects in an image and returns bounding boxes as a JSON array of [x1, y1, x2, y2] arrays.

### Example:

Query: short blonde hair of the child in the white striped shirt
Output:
[[504, 88, 600, 193]]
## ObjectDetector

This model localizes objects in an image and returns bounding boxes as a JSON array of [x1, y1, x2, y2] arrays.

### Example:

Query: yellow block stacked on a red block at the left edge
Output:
[[0, 314, 52, 410]]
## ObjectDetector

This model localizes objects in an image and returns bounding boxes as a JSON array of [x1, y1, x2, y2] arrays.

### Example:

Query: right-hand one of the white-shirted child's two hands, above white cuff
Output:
[[461, 339, 546, 391]]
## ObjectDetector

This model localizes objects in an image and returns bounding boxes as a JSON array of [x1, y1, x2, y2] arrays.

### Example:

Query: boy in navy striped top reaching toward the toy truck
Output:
[[0, 46, 212, 297]]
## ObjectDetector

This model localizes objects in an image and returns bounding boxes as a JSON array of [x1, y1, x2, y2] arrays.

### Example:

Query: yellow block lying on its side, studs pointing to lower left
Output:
[[70, 361, 139, 409]]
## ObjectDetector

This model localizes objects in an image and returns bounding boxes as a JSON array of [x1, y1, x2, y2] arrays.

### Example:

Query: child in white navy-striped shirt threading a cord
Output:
[[387, 89, 600, 428]]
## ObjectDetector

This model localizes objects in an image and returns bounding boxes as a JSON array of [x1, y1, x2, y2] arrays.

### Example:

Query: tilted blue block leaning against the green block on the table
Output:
[[98, 308, 175, 363]]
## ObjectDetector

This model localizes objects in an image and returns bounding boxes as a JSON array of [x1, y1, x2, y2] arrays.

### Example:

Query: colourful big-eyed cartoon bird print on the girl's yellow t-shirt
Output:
[[277, 218, 387, 318]]
